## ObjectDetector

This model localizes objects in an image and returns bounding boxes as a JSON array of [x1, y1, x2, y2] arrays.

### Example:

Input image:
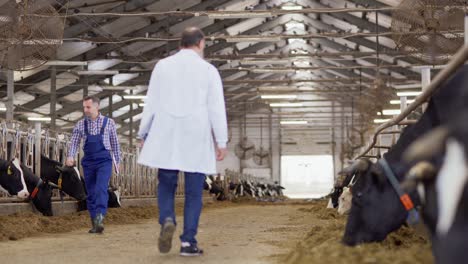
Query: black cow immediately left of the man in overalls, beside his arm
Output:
[[41, 155, 86, 201]]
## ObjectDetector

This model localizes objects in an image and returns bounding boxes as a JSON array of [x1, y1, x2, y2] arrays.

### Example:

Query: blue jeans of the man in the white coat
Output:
[[158, 169, 205, 245]]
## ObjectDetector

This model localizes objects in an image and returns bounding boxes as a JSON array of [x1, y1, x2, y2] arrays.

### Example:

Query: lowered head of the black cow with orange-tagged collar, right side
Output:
[[343, 159, 407, 246]]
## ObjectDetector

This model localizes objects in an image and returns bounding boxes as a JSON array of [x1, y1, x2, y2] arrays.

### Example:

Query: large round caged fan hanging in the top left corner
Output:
[[0, 0, 64, 70]]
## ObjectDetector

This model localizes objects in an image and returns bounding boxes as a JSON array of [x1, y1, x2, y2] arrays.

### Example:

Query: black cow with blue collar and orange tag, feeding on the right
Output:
[[342, 66, 468, 246]]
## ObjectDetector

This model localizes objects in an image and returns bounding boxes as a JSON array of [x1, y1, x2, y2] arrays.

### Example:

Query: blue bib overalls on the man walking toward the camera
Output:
[[81, 117, 112, 219]]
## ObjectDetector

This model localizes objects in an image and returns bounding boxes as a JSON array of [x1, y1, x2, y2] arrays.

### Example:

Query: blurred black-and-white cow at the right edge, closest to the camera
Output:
[[403, 112, 468, 264]]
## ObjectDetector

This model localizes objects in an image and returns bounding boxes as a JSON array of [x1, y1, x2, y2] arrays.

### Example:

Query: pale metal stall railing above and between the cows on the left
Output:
[[0, 120, 165, 203]]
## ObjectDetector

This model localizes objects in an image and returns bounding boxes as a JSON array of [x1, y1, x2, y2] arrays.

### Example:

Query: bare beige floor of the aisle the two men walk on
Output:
[[0, 205, 308, 264]]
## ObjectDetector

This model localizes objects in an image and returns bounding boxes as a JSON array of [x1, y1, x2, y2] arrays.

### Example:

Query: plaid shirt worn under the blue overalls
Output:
[[68, 113, 120, 164]]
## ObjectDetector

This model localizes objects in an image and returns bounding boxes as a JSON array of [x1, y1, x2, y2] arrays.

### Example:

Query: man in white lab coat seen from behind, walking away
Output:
[[138, 28, 228, 256]]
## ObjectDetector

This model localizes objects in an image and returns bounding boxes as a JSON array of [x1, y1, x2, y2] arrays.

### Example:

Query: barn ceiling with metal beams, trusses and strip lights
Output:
[[0, 0, 456, 153]]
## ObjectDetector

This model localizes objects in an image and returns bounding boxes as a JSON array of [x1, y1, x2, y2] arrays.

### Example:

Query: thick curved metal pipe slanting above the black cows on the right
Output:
[[356, 45, 468, 159]]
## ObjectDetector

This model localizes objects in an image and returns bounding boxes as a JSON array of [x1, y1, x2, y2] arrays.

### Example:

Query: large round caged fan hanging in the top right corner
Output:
[[391, 0, 465, 64]]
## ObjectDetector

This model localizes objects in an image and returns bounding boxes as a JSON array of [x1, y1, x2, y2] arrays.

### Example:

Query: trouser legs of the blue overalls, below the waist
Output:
[[83, 160, 112, 218]]
